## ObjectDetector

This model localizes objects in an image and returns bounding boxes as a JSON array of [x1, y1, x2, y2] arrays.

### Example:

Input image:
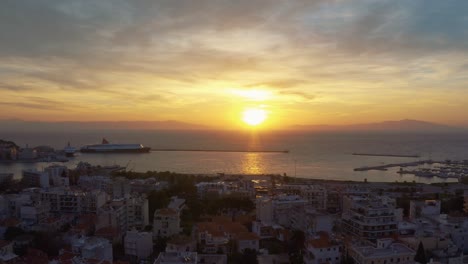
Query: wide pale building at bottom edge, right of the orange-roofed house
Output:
[[348, 238, 416, 264]]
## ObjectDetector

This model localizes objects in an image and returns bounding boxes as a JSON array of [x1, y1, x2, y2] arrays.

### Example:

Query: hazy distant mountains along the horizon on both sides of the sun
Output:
[[0, 119, 462, 132]]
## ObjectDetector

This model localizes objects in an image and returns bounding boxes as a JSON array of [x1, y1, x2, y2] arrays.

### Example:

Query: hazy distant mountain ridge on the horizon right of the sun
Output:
[[294, 119, 466, 132]]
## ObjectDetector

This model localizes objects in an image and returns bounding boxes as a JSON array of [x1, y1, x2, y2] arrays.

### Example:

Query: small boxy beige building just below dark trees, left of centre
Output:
[[153, 208, 181, 237]]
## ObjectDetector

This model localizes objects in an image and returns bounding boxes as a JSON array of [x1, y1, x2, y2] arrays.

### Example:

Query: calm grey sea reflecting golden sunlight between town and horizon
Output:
[[0, 130, 468, 183]]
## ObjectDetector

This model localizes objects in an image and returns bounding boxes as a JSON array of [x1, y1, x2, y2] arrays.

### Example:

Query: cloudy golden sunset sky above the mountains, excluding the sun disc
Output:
[[0, 0, 468, 128]]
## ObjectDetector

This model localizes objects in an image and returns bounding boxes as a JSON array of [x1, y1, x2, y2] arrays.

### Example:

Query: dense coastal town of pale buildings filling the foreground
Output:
[[0, 157, 468, 264]]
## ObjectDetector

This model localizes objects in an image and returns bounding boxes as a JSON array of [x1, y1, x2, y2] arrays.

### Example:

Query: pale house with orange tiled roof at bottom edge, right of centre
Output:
[[304, 232, 343, 264]]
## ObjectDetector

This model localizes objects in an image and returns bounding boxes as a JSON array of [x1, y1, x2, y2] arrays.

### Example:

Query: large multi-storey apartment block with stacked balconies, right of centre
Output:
[[341, 196, 397, 241]]
